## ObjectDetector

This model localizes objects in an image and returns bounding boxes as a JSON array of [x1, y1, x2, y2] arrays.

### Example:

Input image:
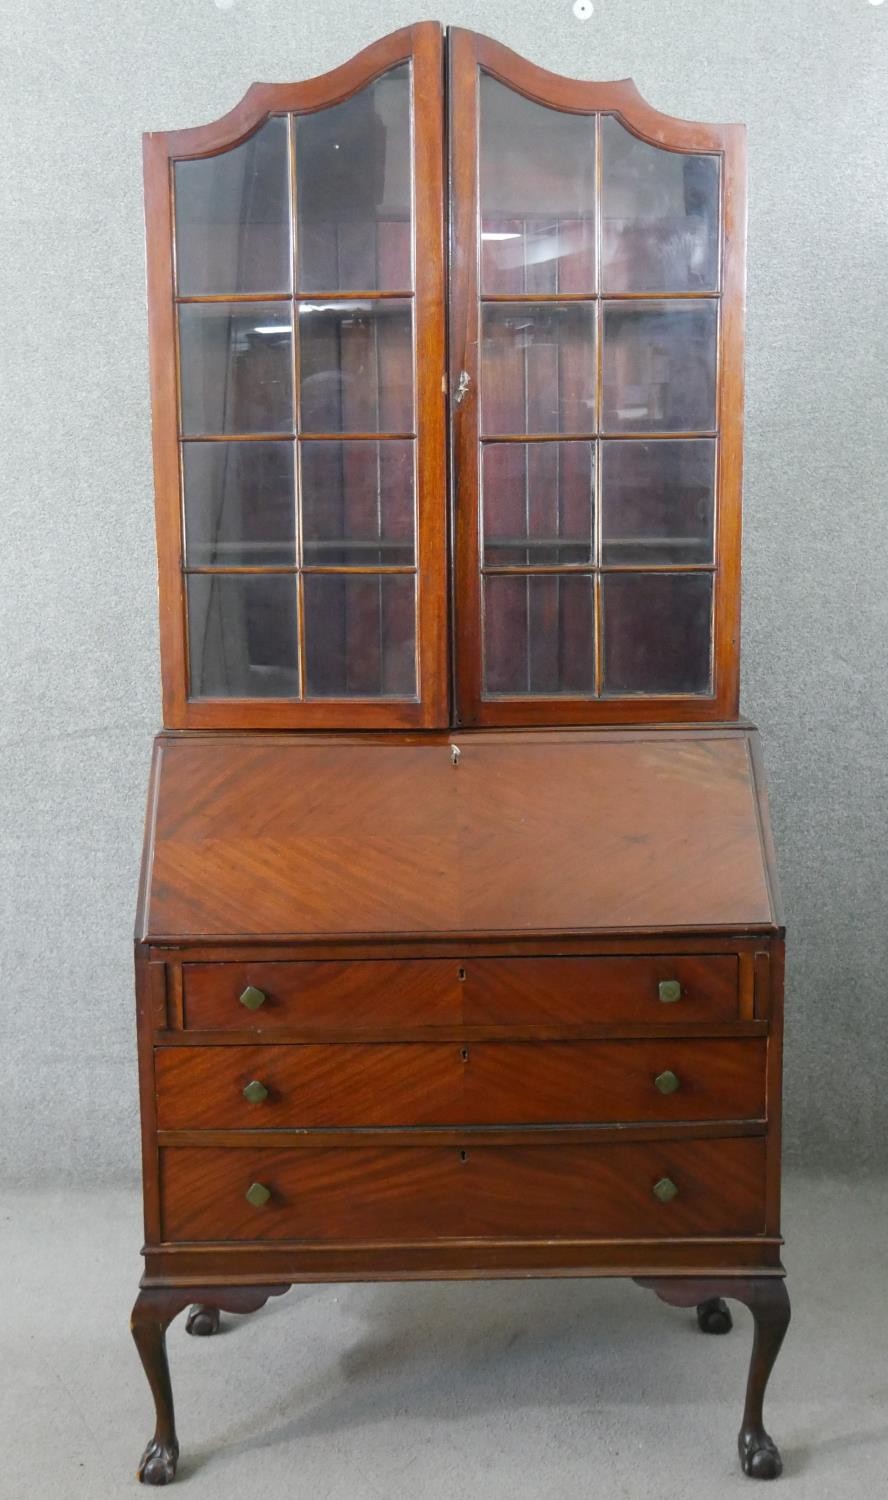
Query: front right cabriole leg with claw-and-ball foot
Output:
[[636, 1277, 791, 1479]]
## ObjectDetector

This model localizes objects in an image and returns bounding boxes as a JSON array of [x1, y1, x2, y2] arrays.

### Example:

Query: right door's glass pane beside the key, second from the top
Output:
[[482, 302, 596, 437]]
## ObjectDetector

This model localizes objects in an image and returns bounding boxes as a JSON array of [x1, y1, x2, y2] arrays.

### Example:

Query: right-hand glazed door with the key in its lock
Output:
[[449, 30, 744, 725]]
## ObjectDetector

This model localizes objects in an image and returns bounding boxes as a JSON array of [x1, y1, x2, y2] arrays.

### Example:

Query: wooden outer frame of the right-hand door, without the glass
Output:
[[449, 29, 746, 726]]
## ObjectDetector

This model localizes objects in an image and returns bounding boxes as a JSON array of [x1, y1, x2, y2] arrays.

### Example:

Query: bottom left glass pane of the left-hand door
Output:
[[188, 573, 299, 698]]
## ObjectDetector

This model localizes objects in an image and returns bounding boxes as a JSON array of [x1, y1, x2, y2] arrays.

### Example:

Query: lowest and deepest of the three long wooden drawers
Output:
[[161, 1137, 765, 1244]]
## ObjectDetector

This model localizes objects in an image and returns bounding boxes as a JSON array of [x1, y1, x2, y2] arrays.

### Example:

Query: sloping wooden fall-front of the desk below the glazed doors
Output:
[[140, 729, 774, 941]]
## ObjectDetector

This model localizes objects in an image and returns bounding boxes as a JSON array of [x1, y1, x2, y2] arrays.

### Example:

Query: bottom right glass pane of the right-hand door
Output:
[[602, 573, 713, 695]]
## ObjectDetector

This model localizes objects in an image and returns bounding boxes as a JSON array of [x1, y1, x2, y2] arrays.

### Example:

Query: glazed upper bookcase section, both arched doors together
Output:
[[146, 23, 744, 729]]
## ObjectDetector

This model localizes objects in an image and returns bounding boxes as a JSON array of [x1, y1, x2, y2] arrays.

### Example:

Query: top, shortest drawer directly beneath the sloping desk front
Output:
[[183, 954, 738, 1034]]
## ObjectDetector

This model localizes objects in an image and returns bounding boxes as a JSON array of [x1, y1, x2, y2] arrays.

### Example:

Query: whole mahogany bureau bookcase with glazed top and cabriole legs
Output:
[[134, 23, 789, 1484]]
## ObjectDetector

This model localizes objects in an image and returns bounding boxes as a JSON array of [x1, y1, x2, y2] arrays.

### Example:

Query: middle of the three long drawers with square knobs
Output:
[[156, 1038, 767, 1130]]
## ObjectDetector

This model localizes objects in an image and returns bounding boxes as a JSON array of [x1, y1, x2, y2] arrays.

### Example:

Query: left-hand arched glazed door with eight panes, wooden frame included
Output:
[[146, 24, 449, 728]]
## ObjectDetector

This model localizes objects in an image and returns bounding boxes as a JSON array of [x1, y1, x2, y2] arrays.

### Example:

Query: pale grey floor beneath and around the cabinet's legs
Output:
[[0, 1179, 888, 1500]]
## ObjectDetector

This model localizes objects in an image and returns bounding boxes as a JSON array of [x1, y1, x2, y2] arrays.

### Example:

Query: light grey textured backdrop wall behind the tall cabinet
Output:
[[0, 0, 888, 1182]]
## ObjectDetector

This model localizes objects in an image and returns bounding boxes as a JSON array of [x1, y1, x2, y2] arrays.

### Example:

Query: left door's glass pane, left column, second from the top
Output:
[[179, 302, 293, 434]]
